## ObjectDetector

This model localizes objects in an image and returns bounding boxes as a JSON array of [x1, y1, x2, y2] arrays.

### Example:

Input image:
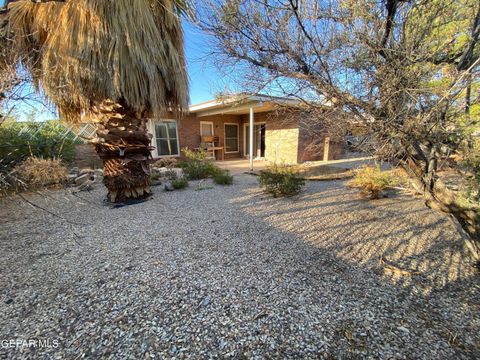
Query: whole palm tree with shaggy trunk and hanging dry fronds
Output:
[[2, 0, 188, 202]]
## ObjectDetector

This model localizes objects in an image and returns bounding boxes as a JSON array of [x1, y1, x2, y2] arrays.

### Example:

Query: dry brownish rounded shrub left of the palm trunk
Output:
[[15, 157, 68, 187]]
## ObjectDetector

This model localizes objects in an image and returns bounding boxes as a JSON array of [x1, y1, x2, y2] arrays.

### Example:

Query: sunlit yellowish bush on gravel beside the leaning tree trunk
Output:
[[347, 165, 398, 199]]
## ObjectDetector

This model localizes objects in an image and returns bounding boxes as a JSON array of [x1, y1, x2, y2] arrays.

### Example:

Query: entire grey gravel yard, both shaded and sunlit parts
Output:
[[0, 175, 480, 359]]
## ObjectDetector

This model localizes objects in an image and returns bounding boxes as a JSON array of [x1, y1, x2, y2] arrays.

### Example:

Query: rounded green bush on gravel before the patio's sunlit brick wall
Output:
[[258, 165, 305, 197]]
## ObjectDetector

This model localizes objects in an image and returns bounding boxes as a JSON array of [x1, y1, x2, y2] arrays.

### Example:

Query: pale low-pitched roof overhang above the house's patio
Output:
[[190, 94, 299, 117]]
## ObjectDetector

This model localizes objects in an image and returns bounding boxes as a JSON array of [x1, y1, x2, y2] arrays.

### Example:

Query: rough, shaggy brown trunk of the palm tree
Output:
[[93, 101, 152, 202]]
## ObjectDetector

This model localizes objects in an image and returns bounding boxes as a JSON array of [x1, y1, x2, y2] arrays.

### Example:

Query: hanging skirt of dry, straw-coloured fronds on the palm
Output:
[[7, 0, 188, 122]]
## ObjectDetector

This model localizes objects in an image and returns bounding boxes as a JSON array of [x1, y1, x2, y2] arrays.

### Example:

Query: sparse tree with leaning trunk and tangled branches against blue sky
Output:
[[197, 0, 480, 260]]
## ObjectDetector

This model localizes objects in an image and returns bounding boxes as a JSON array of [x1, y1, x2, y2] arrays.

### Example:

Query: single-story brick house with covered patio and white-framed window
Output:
[[148, 95, 344, 164]]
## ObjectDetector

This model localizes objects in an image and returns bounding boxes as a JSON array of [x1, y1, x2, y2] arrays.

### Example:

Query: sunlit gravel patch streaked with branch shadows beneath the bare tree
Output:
[[232, 182, 480, 358]]
